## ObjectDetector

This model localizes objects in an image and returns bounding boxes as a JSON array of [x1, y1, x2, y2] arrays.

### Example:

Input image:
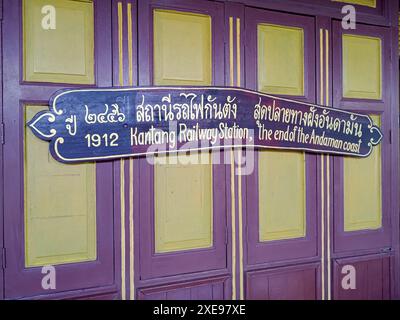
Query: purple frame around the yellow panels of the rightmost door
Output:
[[332, 20, 395, 255]]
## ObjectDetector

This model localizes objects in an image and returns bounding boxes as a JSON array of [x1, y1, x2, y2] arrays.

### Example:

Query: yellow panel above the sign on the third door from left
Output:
[[258, 24, 304, 96]]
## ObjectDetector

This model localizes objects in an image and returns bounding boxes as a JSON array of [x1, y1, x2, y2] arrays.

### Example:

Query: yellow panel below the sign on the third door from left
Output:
[[258, 151, 306, 241]]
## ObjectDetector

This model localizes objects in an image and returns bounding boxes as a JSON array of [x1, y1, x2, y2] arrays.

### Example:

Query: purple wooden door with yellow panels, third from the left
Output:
[[243, 8, 319, 299]]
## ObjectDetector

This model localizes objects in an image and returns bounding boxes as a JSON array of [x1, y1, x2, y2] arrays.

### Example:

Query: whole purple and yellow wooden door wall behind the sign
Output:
[[0, 0, 400, 299]]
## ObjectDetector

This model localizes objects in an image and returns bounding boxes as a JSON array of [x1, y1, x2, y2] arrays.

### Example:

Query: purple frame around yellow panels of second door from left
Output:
[[134, 0, 230, 290]]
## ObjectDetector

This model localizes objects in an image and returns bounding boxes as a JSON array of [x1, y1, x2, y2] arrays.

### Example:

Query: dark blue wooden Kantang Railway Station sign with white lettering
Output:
[[27, 87, 383, 163]]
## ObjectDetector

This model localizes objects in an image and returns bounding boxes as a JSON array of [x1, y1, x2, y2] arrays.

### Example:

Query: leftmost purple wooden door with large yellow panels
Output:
[[3, 0, 114, 298]]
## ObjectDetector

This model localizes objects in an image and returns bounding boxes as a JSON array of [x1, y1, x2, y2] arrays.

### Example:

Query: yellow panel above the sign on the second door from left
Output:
[[154, 10, 212, 85]]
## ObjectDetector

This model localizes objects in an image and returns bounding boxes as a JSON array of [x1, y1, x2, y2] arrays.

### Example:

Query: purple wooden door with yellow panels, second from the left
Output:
[[134, 0, 229, 299]]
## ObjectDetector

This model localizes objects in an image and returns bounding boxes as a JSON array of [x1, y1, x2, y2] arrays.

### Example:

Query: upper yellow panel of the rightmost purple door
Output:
[[343, 34, 382, 100]]
